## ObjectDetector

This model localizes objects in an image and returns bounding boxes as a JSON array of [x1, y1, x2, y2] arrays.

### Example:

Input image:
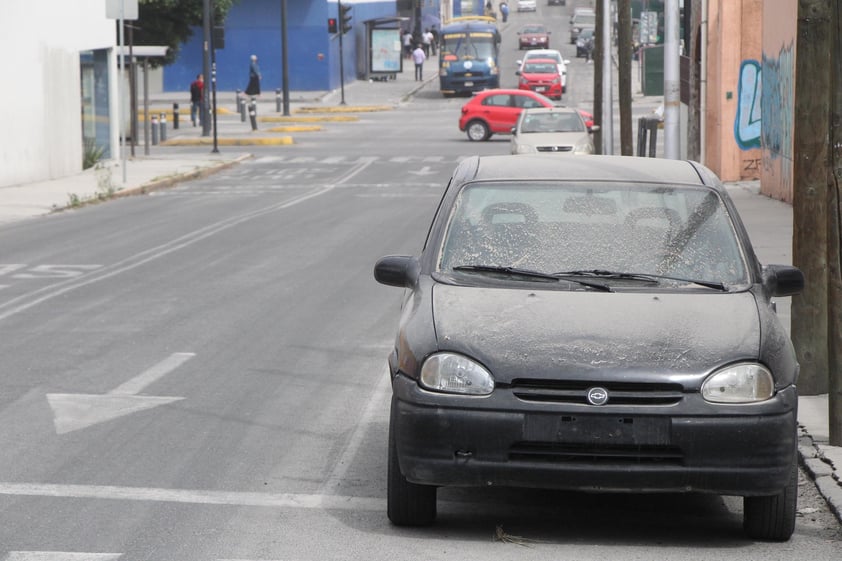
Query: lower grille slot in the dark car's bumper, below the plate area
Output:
[[509, 442, 684, 465]]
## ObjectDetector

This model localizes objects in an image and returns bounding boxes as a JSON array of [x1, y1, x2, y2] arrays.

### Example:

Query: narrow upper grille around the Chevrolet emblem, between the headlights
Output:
[[510, 378, 684, 406]]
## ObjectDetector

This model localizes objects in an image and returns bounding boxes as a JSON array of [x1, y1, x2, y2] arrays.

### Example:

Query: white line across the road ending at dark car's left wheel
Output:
[[0, 483, 386, 512]]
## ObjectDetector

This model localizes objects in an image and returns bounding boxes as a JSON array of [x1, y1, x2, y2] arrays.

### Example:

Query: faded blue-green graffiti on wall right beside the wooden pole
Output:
[[761, 43, 795, 198]]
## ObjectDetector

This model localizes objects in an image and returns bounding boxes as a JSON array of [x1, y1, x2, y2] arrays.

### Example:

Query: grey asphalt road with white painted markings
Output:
[[0, 5, 842, 561]]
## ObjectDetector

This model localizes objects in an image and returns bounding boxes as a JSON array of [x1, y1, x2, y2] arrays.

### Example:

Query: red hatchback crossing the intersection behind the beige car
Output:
[[459, 88, 555, 141]]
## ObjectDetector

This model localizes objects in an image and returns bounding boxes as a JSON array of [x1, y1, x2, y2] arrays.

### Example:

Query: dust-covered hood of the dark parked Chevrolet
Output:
[[433, 284, 760, 383]]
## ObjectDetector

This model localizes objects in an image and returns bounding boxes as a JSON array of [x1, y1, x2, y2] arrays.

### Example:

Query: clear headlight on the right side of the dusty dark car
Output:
[[702, 363, 775, 403]]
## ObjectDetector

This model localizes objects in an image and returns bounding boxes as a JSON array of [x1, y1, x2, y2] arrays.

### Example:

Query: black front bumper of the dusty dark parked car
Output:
[[393, 375, 797, 496]]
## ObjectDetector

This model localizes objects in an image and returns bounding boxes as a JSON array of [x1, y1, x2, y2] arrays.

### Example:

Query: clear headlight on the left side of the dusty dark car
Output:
[[420, 353, 494, 395]]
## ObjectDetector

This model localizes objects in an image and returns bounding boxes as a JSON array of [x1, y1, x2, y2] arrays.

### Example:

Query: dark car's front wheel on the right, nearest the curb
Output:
[[743, 450, 798, 542]]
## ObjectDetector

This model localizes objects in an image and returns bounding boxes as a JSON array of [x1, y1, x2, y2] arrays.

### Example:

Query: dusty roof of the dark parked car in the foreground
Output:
[[454, 154, 712, 190]]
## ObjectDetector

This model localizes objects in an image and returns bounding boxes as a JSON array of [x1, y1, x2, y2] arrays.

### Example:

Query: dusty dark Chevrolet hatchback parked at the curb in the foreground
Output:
[[374, 155, 804, 540]]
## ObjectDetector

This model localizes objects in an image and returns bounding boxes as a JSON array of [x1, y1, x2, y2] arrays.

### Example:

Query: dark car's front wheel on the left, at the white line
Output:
[[386, 399, 436, 526]]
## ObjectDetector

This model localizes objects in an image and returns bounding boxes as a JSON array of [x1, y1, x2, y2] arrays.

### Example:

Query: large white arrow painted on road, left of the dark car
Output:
[[47, 353, 196, 434]]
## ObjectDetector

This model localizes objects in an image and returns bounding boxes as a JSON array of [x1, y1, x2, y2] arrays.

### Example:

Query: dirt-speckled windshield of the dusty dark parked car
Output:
[[438, 181, 748, 287]]
